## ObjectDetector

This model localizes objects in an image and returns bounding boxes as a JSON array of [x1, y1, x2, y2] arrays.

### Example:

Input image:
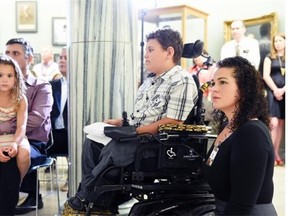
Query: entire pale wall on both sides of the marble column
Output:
[[0, 0, 287, 60]]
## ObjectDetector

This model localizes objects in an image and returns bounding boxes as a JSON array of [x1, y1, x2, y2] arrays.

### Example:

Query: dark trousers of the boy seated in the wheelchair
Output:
[[77, 139, 140, 208]]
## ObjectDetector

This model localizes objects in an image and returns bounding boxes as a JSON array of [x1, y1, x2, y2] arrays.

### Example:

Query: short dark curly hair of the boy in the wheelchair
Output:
[[146, 27, 183, 64]]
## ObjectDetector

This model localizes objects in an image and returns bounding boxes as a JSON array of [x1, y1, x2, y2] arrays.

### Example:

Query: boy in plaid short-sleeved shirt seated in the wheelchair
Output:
[[64, 28, 198, 215]]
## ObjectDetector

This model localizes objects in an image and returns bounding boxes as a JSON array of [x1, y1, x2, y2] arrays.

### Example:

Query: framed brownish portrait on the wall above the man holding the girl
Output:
[[15, 1, 38, 32]]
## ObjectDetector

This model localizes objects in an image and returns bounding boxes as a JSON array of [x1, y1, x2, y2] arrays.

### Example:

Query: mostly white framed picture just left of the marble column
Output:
[[52, 17, 67, 46]]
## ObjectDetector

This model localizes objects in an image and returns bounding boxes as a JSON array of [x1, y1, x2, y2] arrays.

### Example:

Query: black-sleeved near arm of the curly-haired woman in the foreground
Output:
[[224, 123, 274, 215]]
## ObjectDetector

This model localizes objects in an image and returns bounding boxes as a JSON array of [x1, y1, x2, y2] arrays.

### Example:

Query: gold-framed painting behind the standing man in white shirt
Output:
[[224, 12, 278, 41]]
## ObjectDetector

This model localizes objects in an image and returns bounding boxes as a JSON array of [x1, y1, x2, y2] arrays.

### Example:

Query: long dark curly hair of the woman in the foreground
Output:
[[212, 56, 270, 133]]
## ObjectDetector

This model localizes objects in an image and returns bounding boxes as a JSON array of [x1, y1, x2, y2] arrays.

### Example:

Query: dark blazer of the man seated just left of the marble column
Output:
[[50, 78, 67, 129]]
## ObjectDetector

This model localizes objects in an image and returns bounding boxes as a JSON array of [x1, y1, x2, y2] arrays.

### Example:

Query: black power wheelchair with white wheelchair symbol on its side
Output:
[[86, 124, 215, 216]]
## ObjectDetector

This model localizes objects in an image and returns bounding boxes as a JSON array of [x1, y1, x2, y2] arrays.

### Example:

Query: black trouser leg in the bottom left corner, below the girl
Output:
[[0, 158, 20, 215]]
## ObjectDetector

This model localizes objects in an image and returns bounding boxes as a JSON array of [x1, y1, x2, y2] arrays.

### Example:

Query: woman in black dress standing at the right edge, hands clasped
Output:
[[263, 33, 286, 166]]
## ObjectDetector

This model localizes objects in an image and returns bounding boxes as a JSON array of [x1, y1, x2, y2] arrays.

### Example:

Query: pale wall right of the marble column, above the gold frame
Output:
[[184, 0, 286, 60]]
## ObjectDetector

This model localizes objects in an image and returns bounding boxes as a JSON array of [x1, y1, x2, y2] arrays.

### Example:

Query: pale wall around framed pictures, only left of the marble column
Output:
[[0, 0, 69, 56]]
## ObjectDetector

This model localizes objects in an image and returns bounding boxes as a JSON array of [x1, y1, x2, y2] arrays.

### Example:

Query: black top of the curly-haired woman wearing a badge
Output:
[[206, 120, 274, 215]]
